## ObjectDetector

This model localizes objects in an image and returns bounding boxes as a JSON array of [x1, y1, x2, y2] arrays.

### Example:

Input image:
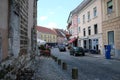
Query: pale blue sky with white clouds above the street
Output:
[[37, 0, 83, 29]]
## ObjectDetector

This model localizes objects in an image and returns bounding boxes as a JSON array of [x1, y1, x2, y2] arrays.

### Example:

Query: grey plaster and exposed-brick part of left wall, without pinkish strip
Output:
[[9, 0, 37, 57]]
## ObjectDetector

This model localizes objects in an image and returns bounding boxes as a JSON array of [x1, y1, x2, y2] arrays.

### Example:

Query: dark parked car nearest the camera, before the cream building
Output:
[[70, 47, 85, 56]]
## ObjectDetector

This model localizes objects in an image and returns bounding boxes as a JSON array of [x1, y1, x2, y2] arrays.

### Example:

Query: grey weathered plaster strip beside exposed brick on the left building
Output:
[[8, 0, 20, 56]]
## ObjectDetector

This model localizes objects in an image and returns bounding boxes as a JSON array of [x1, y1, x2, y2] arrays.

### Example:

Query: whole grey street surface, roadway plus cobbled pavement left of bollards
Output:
[[30, 49, 120, 80]]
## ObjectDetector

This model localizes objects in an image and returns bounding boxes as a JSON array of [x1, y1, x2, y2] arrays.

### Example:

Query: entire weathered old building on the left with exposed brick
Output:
[[0, 0, 37, 61]]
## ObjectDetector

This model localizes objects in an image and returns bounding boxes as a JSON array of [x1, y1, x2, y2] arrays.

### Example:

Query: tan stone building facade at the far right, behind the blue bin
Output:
[[102, 0, 120, 59]]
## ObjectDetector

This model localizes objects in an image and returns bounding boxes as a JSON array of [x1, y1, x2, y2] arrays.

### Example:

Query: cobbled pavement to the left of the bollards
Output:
[[33, 57, 71, 80]]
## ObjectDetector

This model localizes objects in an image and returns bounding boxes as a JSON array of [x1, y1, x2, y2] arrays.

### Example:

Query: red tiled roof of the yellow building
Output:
[[36, 26, 56, 35]]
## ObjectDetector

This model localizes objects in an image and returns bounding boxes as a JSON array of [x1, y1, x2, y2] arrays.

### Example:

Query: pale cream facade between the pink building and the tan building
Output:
[[78, 0, 103, 53]]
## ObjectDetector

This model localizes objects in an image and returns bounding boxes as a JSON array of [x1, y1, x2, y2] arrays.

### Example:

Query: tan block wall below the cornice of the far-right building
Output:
[[103, 17, 120, 58]]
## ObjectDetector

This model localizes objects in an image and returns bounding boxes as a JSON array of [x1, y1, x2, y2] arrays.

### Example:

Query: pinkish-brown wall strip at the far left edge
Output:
[[0, 0, 8, 62]]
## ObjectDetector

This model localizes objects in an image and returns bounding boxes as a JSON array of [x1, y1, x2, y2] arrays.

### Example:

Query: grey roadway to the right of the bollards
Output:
[[52, 48, 120, 80]]
